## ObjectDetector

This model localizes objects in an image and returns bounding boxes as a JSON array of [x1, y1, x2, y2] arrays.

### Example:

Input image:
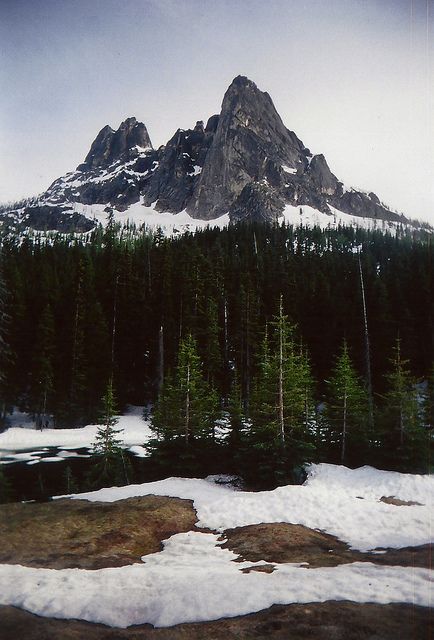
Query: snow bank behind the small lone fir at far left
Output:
[[0, 407, 151, 464]]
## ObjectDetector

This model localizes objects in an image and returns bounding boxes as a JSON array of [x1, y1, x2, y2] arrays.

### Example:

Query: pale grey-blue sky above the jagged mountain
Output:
[[0, 0, 434, 223]]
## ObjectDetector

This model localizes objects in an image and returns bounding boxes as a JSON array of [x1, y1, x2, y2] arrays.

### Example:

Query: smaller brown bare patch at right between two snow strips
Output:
[[222, 523, 432, 569]]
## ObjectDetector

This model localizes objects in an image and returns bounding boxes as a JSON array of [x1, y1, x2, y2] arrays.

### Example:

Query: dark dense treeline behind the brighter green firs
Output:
[[0, 224, 434, 482]]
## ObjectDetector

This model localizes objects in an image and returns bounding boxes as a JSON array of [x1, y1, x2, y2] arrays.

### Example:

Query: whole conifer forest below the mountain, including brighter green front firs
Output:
[[0, 222, 434, 486]]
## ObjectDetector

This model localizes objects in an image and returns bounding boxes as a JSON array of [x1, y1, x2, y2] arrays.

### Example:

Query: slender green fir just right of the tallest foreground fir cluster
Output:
[[324, 340, 369, 464]]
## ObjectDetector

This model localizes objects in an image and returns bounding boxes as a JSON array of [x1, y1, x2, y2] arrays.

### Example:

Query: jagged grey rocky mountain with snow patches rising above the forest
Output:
[[0, 76, 420, 232]]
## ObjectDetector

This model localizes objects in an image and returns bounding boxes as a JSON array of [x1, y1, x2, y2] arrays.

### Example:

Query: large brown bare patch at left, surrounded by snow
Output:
[[0, 496, 197, 569]]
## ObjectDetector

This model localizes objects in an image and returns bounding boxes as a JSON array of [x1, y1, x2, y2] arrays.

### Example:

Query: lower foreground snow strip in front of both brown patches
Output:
[[0, 532, 430, 627]]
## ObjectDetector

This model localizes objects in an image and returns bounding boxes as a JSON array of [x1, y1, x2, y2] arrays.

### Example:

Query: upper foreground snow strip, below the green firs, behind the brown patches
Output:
[[72, 464, 434, 551]]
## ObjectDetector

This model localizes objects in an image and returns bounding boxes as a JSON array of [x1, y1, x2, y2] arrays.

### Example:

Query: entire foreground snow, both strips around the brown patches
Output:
[[0, 464, 434, 627]]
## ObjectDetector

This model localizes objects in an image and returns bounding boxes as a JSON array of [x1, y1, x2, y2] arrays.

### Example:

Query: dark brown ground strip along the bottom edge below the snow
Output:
[[0, 602, 434, 640]]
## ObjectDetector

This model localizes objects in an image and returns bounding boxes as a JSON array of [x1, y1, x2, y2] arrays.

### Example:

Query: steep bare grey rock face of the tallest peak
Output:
[[187, 76, 308, 220]]
